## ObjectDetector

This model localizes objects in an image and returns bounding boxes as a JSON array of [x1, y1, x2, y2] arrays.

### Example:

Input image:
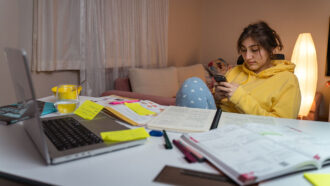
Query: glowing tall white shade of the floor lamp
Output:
[[291, 33, 317, 116]]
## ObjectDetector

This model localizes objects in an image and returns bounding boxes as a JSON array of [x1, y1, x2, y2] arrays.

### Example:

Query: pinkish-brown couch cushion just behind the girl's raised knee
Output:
[[177, 64, 206, 87]]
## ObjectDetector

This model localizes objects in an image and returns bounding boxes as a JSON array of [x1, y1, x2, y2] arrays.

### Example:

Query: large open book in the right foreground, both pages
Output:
[[181, 123, 330, 185]]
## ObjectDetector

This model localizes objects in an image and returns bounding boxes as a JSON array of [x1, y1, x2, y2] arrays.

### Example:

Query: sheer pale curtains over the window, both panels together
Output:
[[33, 0, 169, 96]]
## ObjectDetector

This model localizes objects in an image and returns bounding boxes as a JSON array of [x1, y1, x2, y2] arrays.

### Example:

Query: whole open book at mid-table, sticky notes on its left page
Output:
[[93, 95, 222, 132]]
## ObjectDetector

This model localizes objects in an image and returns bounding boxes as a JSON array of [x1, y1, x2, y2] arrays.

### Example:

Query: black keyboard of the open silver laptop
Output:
[[42, 117, 103, 151]]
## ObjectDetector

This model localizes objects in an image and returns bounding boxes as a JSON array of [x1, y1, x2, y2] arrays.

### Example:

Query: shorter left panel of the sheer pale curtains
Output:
[[32, 0, 81, 71]]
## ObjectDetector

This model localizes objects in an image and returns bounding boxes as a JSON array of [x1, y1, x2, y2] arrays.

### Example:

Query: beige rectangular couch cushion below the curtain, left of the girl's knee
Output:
[[128, 67, 179, 97]]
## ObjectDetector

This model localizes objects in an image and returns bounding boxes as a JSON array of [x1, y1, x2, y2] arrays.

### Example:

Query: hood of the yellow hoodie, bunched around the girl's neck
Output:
[[242, 60, 296, 78]]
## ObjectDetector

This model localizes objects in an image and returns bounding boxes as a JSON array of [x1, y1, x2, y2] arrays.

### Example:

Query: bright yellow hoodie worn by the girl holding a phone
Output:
[[220, 60, 301, 118]]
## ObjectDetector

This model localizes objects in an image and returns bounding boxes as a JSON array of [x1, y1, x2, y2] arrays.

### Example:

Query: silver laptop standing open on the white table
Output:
[[5, 48, 146, 164]]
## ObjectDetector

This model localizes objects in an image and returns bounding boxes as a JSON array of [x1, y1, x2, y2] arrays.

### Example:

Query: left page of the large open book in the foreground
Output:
[[189, 125, 312, 181]]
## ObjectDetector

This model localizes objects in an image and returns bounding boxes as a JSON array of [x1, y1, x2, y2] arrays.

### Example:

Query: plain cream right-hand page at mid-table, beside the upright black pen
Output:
[[147, 106, 221, 132]]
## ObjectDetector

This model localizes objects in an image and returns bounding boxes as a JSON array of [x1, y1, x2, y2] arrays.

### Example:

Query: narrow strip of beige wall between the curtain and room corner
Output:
[[168, 0, 202, 66]]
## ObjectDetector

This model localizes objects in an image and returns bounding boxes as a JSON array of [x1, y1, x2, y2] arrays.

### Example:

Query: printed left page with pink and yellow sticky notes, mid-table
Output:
[[94, 95, 166, 126]]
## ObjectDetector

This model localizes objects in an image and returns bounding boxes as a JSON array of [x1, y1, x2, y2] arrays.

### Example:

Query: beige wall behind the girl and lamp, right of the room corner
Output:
[[200, 0, 330, 118]]
